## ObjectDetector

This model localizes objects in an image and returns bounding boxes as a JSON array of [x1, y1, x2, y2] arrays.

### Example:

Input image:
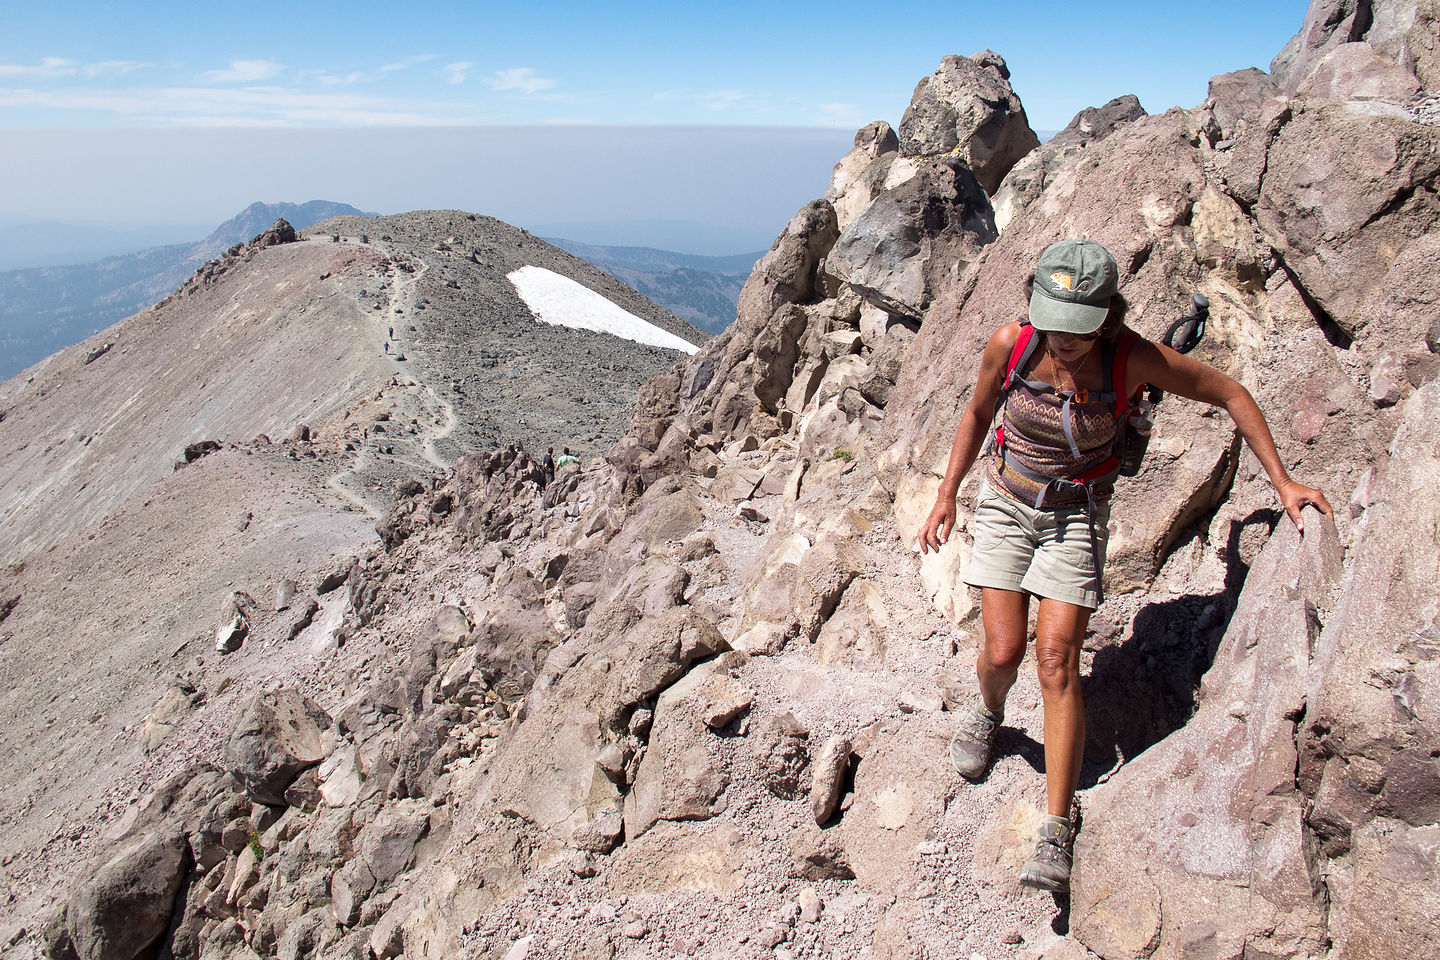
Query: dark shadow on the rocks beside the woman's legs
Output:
[[1080, 510, 1283, 789]]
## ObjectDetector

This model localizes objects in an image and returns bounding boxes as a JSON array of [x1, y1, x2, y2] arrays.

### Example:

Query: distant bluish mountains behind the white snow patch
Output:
[[544, 237, 765, 334]]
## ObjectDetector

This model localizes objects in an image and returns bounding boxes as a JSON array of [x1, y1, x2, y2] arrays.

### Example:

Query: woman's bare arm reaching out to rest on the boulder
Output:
[[1125, 341, 1333, 530]]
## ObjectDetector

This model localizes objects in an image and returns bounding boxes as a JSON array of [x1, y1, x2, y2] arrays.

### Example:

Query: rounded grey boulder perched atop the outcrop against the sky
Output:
[[900, 50, 1040, 193]]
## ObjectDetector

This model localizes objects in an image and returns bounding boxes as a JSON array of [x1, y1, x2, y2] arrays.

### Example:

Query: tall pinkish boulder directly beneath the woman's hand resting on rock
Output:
[[1071, 511, 1341, 960]]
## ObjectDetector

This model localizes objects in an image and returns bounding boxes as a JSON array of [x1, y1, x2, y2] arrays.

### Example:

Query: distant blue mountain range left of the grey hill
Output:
[[0, 200, 369, 380]]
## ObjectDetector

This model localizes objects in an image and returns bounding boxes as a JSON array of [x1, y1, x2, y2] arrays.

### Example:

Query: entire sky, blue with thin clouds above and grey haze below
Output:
[[0, 0, 1306, 253]]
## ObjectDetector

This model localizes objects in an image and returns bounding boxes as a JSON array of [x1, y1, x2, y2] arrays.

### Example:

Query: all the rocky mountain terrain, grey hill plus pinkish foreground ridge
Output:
[[0, 0, 1440, 960]]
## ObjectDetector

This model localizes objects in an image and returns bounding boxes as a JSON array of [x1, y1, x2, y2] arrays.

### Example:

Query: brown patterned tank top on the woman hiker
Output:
[[986, 351, 1115, 508]]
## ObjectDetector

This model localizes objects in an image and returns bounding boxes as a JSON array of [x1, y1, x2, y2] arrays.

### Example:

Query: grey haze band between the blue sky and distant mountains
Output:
[[0, 127, 852, 255]]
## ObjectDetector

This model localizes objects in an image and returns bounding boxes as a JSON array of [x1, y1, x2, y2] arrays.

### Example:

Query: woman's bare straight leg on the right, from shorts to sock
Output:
[[1036, 599, 1090, 819]]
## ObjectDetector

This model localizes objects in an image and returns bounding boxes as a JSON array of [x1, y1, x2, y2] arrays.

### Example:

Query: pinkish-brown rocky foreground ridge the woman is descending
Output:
[[2, 0, 1440, 960]]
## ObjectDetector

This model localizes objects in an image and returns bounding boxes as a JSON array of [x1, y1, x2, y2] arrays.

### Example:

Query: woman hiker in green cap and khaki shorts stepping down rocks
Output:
[[917, 240, 1332, 891]]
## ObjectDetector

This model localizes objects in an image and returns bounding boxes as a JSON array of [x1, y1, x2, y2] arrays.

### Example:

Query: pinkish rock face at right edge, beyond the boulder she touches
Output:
[[1299, 383, 1440, 957]]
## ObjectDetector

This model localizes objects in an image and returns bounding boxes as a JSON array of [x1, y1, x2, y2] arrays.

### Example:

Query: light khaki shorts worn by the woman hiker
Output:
[[965, 482, 1110, 610]]
